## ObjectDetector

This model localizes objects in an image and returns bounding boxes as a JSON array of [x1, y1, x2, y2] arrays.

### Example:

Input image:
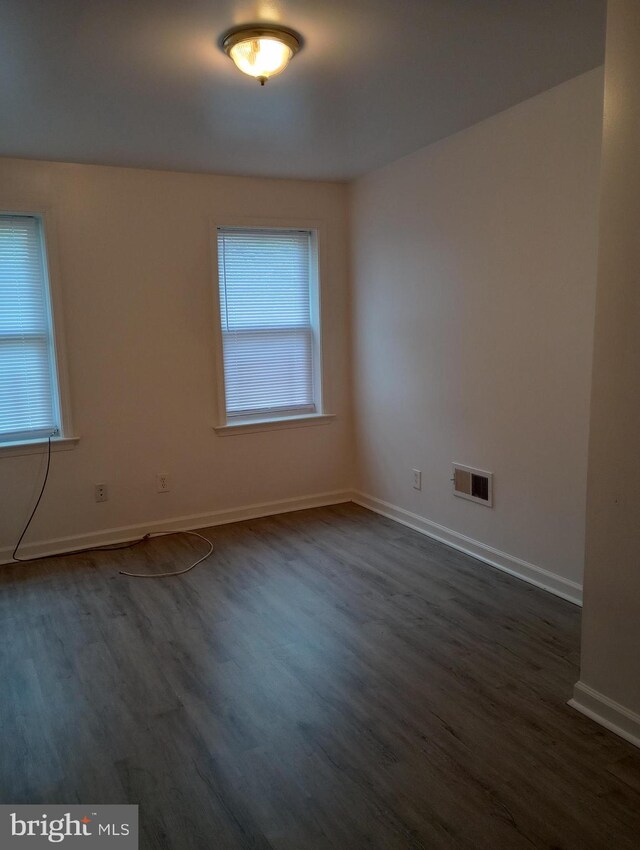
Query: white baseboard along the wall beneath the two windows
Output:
[[0, 490, 353, 565]]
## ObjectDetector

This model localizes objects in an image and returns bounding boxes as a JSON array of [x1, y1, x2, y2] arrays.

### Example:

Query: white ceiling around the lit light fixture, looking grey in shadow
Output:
[[0, 0, 606, 180]]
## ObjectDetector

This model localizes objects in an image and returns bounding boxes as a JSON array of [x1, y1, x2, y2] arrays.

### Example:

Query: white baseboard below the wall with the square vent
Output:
[[352, 493, 582, 605]]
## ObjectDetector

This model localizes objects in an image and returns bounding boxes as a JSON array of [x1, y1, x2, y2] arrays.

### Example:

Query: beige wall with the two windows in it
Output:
[[0, 160, 351, 559]]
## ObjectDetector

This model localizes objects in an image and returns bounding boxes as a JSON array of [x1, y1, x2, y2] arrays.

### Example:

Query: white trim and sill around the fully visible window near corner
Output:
[[208, 216, 334, 436]]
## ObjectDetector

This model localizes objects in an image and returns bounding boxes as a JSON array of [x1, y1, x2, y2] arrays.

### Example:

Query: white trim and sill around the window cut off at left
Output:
[[0, 203, 78, 450]]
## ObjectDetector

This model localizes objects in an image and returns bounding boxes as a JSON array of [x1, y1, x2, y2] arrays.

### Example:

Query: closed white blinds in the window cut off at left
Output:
[[0, 215, 59, 443]]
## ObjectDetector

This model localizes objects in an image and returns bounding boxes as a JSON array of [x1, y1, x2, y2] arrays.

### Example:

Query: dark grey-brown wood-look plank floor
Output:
[[0, 505, 640, 850]]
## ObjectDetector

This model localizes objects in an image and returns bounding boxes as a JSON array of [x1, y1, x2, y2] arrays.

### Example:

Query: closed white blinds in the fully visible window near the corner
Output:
[[218, 228, 316, 418]]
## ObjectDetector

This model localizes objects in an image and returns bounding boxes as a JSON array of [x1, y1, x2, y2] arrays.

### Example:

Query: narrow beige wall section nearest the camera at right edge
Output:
[[576, 0, 640, 724]]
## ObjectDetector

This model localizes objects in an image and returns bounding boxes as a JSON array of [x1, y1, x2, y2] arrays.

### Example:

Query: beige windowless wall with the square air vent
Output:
[[351, 70, 603, 595]]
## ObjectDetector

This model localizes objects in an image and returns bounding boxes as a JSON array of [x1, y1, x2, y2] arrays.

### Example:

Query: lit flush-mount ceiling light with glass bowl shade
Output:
[[220, 24, 302, 86]]
